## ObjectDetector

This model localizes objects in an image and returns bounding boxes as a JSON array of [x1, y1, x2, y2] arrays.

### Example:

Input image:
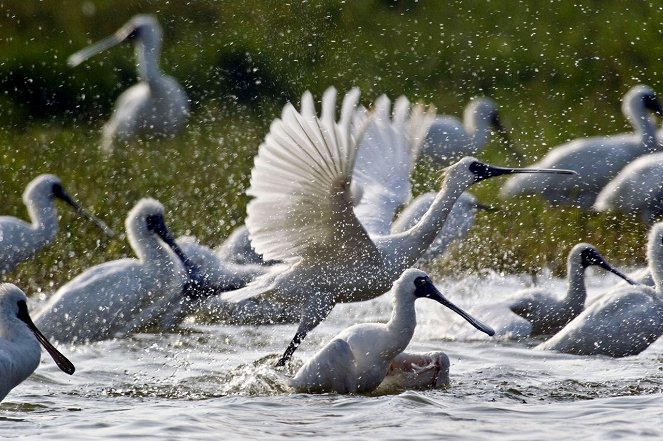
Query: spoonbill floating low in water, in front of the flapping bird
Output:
[[290, 269, 494, 394]]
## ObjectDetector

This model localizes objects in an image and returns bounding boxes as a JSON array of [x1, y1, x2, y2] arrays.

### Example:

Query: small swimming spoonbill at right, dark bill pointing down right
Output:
[[464, 243, 638, 339]]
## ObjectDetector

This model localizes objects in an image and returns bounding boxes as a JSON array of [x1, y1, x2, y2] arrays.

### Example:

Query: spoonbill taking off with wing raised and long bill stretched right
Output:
[[221, 88, 573, 365]]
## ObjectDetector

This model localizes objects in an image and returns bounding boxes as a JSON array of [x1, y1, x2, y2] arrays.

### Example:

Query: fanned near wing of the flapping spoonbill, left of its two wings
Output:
[[246, 88, 378, 262]]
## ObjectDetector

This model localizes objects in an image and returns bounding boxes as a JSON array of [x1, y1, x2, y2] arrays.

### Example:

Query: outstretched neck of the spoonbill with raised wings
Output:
[[376, 176, 468, 269]]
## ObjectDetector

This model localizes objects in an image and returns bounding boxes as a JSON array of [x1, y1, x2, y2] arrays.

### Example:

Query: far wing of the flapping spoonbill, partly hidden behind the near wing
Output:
[[352, 95, 435, 235]]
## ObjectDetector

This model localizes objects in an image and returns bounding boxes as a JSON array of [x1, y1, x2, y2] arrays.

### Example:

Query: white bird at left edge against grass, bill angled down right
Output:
[[0, 175, 113, 274]]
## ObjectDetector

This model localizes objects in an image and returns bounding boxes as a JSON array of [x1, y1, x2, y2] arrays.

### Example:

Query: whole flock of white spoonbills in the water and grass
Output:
[[0, 15, 663, 400]]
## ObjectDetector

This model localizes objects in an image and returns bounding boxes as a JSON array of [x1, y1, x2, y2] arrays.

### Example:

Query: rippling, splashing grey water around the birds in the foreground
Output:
[[0, 274, 663, 440]]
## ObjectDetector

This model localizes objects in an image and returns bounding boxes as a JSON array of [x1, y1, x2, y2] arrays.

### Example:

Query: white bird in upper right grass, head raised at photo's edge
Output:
[[500, 85, 663, 208]]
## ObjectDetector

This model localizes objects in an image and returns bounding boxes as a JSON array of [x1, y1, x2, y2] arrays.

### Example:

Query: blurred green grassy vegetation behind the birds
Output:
[[0, 0, 663, 291]]
